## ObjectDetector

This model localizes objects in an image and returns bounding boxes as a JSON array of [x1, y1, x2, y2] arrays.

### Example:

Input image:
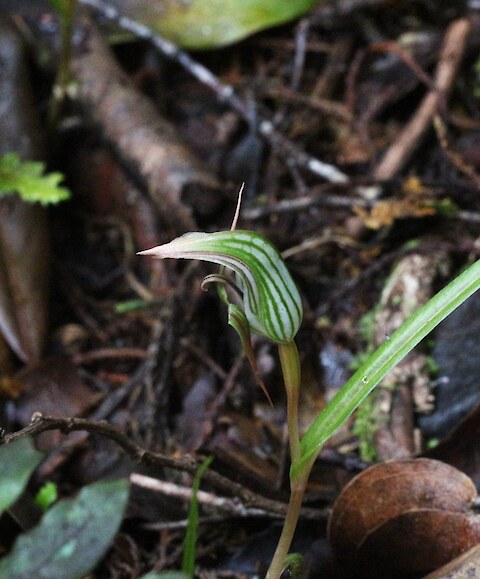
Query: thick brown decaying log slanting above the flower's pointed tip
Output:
[[72, 19, 219, 233]]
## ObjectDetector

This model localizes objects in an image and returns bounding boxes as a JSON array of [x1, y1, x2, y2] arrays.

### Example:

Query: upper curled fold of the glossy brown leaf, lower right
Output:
[[328, 459, 477, 568]]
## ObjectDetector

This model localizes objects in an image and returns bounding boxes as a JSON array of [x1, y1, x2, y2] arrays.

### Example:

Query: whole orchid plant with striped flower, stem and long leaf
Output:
[[141, 214, 480, 579]]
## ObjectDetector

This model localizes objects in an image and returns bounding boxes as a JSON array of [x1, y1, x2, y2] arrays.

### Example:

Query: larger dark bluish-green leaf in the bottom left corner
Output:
[[0, 480, 129, 579]]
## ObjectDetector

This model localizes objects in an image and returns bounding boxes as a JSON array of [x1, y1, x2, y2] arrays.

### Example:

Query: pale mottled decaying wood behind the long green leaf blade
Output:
[[375, 253, 445, 460]]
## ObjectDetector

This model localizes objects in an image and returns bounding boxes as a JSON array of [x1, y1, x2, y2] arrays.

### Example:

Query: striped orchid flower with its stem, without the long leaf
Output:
[[140, 229, 306, 579]]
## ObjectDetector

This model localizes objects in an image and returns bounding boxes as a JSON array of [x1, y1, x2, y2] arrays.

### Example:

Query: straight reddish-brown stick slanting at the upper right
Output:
[[374, 18, 470, 181]]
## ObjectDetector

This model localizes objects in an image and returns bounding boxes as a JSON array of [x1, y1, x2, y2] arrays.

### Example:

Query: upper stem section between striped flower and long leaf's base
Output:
[[278, 340, 301, 463]]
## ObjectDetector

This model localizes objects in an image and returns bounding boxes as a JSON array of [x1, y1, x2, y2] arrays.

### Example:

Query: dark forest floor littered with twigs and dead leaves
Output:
[[0, 0, 480, 579]]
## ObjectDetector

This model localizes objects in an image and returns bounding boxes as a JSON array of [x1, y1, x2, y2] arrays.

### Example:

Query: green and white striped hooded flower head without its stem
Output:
[[141, 230, 303, 344]]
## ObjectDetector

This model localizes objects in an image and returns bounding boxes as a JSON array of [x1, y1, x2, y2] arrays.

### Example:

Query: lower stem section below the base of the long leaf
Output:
[[265, 462, 313, 579]]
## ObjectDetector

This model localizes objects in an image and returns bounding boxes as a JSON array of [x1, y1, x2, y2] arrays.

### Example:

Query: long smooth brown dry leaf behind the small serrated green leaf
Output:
[[0, 18, 49, 361]]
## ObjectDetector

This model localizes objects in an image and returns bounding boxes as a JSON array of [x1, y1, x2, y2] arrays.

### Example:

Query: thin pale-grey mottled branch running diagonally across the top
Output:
[[80, 0, 350, 183]]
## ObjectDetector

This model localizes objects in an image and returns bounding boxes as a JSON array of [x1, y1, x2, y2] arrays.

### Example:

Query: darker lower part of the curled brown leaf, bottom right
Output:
[[356, 509, 480, 579]]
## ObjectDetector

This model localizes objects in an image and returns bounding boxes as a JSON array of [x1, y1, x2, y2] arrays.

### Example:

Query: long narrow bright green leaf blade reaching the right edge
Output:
[[291, 260, 480, 478]]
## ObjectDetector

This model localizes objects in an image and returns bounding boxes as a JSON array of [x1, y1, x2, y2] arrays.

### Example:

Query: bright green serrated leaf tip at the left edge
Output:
[[0, 153, 70, 205]]
